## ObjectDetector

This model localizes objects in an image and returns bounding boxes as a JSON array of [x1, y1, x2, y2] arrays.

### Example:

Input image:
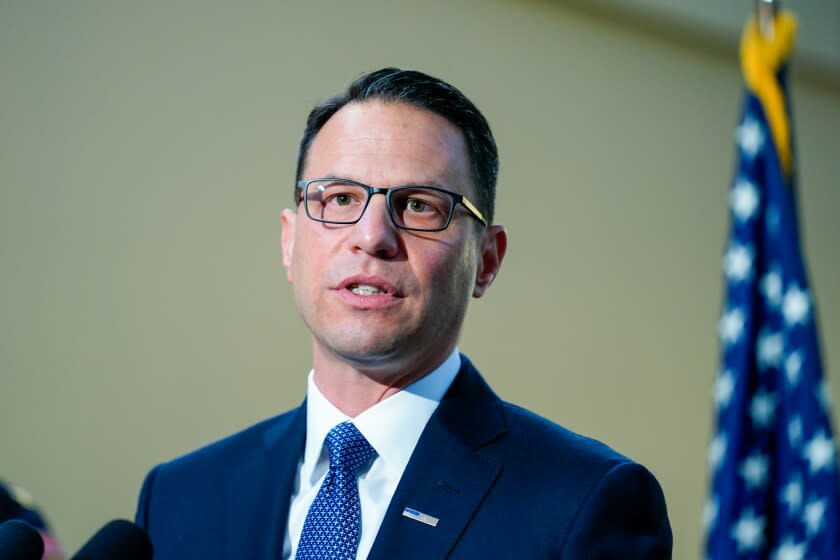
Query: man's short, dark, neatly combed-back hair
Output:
[[296, 68, 499, 223]]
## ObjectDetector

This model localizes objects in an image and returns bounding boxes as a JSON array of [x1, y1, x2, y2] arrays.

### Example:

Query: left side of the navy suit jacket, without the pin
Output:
[[135, 407, 306, 560]]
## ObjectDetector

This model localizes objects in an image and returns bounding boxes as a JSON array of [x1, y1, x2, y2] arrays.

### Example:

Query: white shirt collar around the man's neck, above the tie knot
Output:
[[301, 348, 461, 479]]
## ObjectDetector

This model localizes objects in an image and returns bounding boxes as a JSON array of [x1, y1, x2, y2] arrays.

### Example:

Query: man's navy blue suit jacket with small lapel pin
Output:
[[141, 356, 671, 560]]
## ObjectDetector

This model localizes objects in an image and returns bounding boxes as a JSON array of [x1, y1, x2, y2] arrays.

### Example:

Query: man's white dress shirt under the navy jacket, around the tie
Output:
[[283, 348, 461, 560]]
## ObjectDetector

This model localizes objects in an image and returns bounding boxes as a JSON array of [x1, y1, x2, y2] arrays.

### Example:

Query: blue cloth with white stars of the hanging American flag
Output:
[[703, 14, 840, 560]]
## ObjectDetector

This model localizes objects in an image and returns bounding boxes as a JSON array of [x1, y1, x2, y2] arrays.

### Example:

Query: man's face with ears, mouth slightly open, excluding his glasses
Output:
[[282, 101, 504, 381]]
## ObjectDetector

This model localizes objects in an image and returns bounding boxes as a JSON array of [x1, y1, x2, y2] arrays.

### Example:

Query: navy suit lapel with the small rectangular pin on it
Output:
[[368, 356, 505, 560]]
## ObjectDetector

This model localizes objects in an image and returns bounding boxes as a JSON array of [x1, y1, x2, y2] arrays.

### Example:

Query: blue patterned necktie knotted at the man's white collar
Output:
[[295, 422, 376, 560]]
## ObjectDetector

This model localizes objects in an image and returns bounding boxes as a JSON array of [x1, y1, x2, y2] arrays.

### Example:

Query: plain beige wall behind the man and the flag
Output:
[[0, 0, 840, 558]]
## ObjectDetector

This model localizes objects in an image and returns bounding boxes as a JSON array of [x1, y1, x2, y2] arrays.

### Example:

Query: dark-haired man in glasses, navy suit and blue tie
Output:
[[137, 68, 671, 560]]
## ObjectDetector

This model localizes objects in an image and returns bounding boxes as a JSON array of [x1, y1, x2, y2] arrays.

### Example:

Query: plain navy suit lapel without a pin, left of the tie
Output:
[[224, 403, 306, 560]]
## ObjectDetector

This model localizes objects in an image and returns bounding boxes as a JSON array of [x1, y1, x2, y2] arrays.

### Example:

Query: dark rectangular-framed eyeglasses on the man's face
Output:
[[295, 177, 487, 231]]
